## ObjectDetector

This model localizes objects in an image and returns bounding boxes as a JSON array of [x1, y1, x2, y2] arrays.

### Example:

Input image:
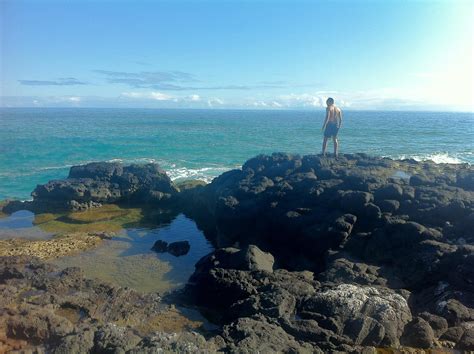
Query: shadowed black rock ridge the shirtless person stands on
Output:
[[187, 153, 474, 272]]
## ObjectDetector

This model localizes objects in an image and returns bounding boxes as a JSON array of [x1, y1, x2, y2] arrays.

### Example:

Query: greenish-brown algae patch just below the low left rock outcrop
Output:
[[33, 204, 143, 235]]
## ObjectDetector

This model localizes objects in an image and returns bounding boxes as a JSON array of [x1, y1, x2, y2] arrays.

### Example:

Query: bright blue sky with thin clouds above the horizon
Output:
[[0, 0, 474, 111]]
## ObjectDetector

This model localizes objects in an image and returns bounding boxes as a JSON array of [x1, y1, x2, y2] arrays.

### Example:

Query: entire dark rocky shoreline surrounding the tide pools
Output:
[[0, 153, 474, 352]]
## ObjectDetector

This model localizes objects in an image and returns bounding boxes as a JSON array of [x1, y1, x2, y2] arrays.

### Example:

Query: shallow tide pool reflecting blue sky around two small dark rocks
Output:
[[52, 214, 213, 293]]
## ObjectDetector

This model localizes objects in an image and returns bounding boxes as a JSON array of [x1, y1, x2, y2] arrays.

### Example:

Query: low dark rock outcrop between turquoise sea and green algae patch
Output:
[[25, 162, 178, 212]]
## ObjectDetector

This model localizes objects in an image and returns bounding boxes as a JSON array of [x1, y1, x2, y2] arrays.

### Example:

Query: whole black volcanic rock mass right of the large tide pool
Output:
[[182, 153, 474, 351]]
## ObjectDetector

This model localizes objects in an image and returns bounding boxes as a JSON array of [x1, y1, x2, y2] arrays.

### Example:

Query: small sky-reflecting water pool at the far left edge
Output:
[[0, 210, 53, 240]]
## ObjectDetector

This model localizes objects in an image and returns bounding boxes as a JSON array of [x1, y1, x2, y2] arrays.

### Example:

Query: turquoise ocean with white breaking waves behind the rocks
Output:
[[0, 108, 474, 200]]
